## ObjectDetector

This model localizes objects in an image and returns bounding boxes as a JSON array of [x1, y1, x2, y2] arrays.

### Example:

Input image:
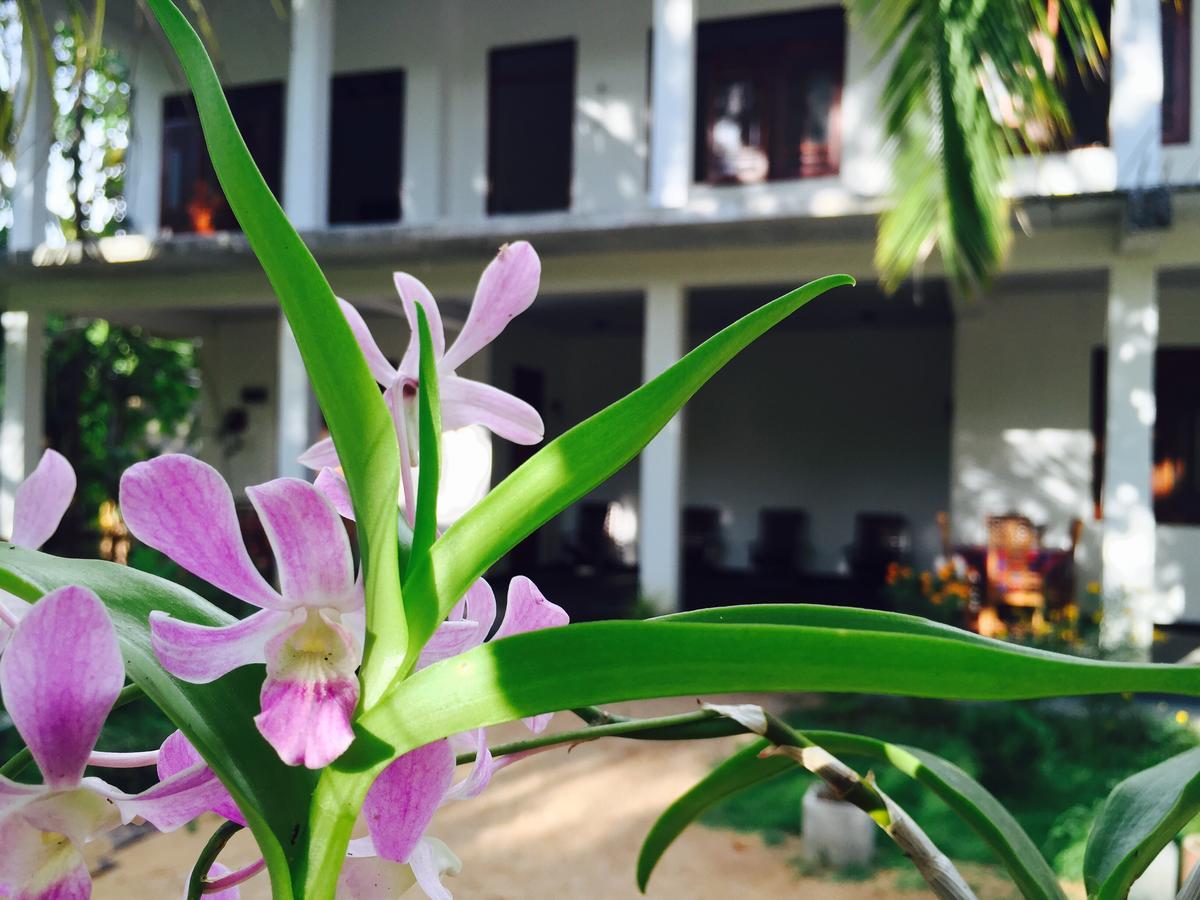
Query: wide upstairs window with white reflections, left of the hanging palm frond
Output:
[[696, 7, 846, 184]]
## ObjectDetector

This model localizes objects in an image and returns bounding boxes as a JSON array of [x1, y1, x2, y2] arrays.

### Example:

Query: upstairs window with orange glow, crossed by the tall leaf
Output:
[[161, 82, 283, 234]]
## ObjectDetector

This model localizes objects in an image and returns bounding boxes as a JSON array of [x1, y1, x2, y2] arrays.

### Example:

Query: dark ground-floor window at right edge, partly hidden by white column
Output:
[[1092, 347, 1200, 524]]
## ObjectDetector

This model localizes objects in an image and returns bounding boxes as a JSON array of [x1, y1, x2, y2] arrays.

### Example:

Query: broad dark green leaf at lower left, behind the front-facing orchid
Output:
[[0, 544, 317, 900]]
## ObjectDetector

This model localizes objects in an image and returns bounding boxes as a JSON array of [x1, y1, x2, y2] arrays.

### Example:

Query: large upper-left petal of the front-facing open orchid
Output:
[[121, 454, 283, 610]]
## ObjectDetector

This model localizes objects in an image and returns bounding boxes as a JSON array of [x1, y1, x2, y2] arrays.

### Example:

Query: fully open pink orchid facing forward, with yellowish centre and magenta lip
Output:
[[121, 454, 362, 769]]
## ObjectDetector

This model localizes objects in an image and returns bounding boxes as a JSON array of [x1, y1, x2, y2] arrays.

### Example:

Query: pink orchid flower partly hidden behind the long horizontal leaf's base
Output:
[[338, 576, 569, 900]]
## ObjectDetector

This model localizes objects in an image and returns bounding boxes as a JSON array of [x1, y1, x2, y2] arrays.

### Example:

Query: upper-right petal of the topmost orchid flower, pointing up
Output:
[[442, 241, 541, 372]]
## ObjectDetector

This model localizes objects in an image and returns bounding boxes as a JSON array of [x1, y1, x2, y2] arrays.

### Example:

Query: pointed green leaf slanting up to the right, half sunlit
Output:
[[406, 275, 854, 667]]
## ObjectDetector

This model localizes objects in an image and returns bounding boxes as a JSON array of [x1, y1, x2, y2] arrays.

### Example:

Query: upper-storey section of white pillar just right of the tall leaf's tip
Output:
[[283, 0, 334, 232]]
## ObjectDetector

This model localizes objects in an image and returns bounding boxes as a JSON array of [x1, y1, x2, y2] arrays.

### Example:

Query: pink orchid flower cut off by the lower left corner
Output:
[[0, 587, 231, 900]]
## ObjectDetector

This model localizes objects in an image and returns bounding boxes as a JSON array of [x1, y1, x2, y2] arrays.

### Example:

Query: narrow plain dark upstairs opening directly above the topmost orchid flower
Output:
[[487, 41, 575, 212]]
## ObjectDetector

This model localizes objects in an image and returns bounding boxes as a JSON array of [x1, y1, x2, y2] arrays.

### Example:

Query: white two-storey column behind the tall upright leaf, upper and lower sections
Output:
[[275, 0, 334, 478]]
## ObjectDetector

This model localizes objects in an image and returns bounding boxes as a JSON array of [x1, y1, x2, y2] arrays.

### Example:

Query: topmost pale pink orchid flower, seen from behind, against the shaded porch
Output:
[[300, 241, 545, 520]]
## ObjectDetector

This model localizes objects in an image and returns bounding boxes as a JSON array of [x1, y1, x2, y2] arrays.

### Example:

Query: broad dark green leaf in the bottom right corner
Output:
[[1084, 748, 1200, 900]]
